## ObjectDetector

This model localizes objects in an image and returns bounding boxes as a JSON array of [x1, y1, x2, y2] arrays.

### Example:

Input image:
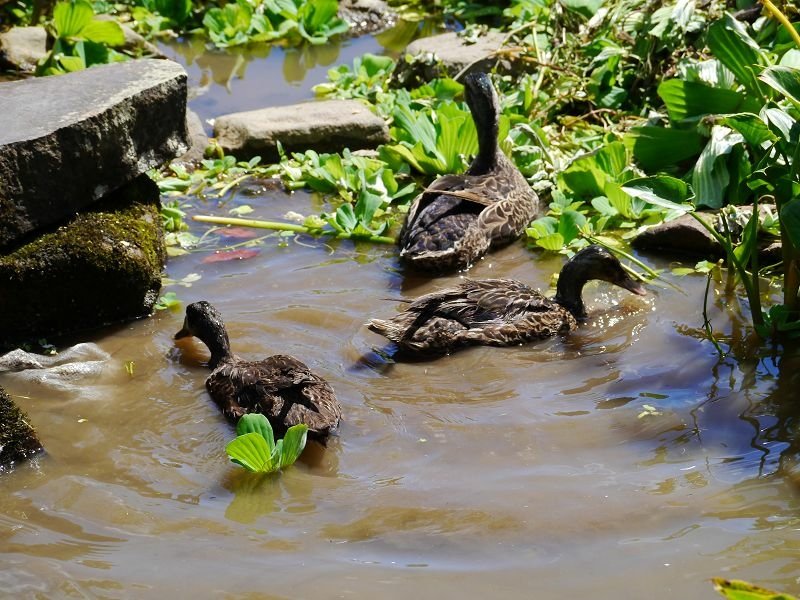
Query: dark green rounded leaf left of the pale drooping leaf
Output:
[[623, 126, 703, 171]]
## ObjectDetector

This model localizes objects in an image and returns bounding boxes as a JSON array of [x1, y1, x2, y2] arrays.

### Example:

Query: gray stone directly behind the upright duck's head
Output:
[[394, 31, 506, 86]]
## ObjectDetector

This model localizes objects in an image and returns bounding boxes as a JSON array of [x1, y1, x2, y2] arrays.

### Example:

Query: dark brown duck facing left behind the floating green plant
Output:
[[175, 300, 342, 444]]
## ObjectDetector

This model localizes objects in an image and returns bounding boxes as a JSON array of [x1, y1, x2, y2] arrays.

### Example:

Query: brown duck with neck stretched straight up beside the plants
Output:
[[398, 72, 541, 271]]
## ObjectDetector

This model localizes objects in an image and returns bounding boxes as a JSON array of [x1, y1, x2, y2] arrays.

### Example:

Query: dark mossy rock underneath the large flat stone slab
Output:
[[0, 175, 165, 347]]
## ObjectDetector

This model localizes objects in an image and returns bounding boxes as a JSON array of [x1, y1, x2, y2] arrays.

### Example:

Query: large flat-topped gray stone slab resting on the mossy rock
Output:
[[0, 59, 186, 248]]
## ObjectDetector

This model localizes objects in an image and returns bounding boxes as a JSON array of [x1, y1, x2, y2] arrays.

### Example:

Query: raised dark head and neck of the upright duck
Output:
[[464, 73, 500, 174]]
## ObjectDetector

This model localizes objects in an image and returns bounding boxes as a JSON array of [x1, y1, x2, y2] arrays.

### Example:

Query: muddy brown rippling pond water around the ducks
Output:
[[0, 25, 800, 600]]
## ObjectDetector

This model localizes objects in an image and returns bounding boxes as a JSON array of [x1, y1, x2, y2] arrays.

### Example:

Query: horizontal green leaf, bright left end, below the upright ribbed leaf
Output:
[[658, 79, 745, 121]]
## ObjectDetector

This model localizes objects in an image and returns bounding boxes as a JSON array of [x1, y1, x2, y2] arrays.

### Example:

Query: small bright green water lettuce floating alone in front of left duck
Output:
[[225, 413, 308, 473]]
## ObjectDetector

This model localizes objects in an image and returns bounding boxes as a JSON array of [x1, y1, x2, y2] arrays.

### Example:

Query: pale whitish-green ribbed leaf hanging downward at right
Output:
[[692, 125, 744, 208]]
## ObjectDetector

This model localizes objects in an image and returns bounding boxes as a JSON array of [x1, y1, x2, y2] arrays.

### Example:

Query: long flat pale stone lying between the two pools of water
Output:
[[214, 100, 389, 160]]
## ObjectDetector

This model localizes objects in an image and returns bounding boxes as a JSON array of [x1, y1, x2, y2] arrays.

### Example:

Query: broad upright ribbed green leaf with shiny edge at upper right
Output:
[[706, 13, 768, 98]]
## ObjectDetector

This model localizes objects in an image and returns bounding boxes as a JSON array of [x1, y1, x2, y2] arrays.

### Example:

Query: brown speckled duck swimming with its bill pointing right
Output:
[[367, 245, 647, 354]]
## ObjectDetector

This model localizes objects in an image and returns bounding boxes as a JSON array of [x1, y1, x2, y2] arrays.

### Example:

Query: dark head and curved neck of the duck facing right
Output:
[[555, 245, 647, 319]]
